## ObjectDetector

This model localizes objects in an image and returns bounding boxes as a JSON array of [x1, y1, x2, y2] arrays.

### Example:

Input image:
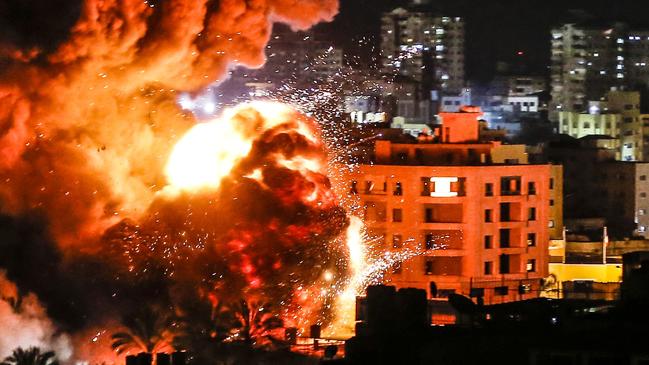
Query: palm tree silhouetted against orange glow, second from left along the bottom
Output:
[[111, 306, 177, 354]]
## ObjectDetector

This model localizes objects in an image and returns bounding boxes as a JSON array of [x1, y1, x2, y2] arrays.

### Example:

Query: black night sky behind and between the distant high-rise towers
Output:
[[323, 0, 649, 80]]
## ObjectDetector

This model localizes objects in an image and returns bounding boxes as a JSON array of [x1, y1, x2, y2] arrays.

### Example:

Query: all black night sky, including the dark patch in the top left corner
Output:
[[0, 0, 649, 81]]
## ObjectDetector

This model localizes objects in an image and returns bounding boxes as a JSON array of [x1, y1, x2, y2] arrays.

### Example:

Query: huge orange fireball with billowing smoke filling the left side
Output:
[[0, 0, 348, 360]]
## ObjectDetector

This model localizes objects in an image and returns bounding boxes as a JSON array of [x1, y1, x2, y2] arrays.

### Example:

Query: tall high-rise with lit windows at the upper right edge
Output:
[[550, 23, 649, 121]]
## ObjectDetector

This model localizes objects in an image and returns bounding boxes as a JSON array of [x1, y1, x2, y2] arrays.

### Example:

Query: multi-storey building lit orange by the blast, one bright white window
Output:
[[350, 108, 561, 303]]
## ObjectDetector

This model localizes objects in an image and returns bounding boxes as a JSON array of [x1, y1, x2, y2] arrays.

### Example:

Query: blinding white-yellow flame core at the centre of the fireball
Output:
[[165, 101, 324, 199]]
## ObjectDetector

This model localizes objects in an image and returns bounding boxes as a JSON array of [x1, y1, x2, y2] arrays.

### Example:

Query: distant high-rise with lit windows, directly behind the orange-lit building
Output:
[[381, 8, 465, 93]]
